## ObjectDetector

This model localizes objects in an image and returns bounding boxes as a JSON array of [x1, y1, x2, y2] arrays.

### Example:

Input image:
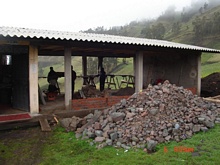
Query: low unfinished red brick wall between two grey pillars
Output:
[[72, 96, 130, 110]]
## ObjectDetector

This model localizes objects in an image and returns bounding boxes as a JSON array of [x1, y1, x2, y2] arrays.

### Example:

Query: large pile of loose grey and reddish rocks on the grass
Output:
[[60, 81, 220, 149]]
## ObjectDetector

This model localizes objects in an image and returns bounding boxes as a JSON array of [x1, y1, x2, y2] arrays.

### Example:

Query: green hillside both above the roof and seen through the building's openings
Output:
[[39, 0, 220, 92]]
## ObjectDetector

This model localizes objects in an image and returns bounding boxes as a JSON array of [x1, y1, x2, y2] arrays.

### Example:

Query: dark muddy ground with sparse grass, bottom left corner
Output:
[[0, 126, 52, 165]]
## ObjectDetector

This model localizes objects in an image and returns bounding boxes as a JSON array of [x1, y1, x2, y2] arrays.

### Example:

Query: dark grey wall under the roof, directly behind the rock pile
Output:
[[143, 51, 201, 93]]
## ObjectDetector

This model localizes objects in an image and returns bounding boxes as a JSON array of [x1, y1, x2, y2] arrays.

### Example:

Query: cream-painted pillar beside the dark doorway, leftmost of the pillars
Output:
[[29, 45, 39, 114]]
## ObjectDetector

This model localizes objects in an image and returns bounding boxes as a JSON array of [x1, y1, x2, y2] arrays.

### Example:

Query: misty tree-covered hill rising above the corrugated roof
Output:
[[83, 0, 220, 48]]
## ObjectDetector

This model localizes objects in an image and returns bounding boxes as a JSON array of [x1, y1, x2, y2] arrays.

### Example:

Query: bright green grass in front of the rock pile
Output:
[[41, 125, 220, 165]]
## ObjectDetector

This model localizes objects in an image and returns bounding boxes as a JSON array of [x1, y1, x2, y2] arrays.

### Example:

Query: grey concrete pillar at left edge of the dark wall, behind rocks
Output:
[[134, 52, 143, 92]]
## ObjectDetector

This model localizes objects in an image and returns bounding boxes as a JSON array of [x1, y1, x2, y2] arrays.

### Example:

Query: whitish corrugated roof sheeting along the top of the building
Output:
[[0, 27, 220, 53]]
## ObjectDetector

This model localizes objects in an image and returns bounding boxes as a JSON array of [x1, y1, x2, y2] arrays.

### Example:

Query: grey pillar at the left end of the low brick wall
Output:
[[64, 47, 72, 110]]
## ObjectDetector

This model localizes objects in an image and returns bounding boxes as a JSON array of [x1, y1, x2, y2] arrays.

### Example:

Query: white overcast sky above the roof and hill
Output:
[[0, 0, 191, 32]]
